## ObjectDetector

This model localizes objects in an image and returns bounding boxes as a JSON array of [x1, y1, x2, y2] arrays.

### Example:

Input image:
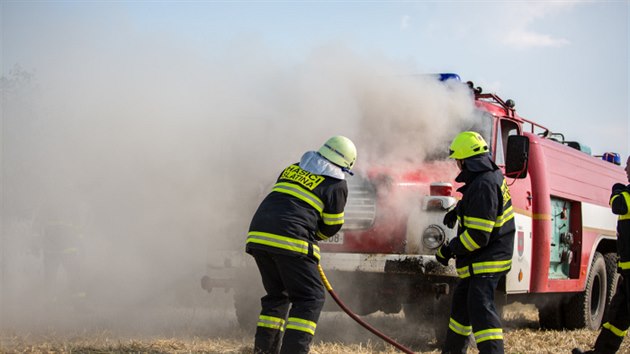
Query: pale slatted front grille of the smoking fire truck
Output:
[[342, 174, 376, 231]]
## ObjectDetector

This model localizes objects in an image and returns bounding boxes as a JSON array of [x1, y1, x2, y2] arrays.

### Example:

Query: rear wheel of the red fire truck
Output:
[[564, 252, 608, 330]]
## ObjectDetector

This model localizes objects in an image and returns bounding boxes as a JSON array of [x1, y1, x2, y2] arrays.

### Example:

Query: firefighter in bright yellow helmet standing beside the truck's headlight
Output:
[[436, 132, 515, 354]]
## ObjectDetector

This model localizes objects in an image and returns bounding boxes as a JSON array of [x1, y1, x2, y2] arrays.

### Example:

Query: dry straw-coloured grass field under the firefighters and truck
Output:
[[0, 305, 630, 354]]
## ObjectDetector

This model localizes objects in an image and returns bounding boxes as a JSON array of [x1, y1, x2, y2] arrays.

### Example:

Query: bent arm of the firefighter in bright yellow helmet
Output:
[[450, 183, 499, 255]]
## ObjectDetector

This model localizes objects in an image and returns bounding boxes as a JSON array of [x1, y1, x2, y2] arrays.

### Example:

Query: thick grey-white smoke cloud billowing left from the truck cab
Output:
[[0, 18, 473, 334]]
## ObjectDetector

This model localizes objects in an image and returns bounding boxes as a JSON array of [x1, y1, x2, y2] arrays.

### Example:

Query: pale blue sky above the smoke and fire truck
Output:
[[1, 1, 630, 156]]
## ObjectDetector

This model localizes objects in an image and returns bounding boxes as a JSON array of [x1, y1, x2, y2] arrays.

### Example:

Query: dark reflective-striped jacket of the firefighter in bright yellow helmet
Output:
[[449, 154, 515, 278]]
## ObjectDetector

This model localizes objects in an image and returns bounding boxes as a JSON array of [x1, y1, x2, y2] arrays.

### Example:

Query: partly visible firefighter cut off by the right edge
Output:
[[573, 157, 630, 354]]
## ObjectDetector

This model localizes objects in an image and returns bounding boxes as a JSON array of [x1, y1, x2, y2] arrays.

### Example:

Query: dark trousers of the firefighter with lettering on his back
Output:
[[251, 250, 326, 354]]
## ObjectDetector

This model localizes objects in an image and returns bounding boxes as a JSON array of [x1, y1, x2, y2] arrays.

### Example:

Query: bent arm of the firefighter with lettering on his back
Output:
[[316, 183, 348, 240]]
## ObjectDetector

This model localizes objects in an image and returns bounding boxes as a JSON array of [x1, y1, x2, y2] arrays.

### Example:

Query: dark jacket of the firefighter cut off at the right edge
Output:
[[610, 185, 630, 269]]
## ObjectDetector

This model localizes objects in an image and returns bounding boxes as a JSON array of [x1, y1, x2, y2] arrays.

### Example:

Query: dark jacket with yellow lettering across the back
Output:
[[246, 163, 348, 260]]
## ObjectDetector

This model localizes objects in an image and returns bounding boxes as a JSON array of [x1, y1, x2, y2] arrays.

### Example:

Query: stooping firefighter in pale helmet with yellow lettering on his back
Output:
[[246, 136, 357, 354]]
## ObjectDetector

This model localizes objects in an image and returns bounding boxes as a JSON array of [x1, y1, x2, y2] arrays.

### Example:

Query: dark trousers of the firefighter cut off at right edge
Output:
[[595, 270, 630, 354]]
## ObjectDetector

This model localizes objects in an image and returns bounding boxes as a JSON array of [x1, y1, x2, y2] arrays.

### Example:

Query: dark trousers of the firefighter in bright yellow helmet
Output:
[[442, 274, 504, 354]]
